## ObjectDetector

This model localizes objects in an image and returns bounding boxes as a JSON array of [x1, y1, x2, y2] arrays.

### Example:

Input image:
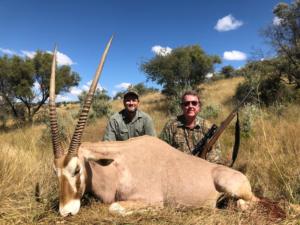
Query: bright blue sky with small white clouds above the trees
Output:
[[0, 0, 290, 100]]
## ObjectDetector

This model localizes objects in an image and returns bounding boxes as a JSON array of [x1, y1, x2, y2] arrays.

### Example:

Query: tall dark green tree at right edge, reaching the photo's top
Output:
[[236, 0, 300, 106]]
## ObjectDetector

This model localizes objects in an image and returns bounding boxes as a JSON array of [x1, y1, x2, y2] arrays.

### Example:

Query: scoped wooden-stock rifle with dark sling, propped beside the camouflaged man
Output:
[[192, 89, 253, 163]]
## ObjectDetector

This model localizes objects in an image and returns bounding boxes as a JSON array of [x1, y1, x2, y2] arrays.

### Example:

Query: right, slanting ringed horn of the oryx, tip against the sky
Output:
[[68, 36, 113, 156]]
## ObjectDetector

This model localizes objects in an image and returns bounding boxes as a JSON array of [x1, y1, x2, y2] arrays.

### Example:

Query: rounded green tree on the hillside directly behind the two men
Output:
[[141, 45, 221, 97]]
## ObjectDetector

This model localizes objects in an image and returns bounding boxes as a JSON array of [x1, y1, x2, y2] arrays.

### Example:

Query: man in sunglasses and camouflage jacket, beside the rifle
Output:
[[160, 91, 223, 164]]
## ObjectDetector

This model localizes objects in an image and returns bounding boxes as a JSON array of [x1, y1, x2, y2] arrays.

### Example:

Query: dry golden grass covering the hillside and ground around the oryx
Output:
[[0, 78, 300, 225]]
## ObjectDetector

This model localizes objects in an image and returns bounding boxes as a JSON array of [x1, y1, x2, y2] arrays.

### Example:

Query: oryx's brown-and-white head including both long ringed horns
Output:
[[49, 37, 113, 216]]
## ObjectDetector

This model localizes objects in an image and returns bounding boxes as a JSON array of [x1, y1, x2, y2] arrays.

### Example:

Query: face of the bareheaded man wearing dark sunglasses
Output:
[[181, 95, 200, 117]]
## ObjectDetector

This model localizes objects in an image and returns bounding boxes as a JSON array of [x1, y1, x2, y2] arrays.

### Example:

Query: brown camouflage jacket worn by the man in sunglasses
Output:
[[160, 115, 223, 163]]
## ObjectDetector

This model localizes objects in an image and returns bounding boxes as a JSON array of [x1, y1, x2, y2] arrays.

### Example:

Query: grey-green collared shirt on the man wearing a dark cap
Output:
[[103, 109, 156, 141]]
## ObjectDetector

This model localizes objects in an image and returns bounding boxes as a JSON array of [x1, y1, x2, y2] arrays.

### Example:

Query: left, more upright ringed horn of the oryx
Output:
[[49, 46, 64, 158]]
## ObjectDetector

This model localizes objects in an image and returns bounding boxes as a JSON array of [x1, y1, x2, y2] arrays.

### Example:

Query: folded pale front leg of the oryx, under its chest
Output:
[[109, 201, 163, 216]]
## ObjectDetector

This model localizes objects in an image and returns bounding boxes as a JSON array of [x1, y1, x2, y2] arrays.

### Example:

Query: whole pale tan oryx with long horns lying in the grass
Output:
[[49, 39, 257, 216]]
